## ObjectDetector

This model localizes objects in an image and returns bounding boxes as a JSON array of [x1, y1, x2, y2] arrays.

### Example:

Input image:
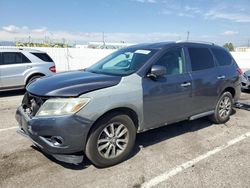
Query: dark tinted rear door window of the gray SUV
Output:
[[188, 48, 214, 71]]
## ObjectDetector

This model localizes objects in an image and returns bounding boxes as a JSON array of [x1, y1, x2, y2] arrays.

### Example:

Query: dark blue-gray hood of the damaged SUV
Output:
[[26, 71, 121, 97]]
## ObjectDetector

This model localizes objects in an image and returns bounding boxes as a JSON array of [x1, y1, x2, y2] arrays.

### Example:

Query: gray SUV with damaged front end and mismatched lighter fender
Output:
[[16, 42, 241, 167]]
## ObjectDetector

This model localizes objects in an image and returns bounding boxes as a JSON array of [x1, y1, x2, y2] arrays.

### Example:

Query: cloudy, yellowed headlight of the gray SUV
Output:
[[36, 98, 90, 116]]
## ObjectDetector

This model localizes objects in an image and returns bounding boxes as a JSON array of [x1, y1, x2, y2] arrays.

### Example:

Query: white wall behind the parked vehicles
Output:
[[0, 47, 250, 72]]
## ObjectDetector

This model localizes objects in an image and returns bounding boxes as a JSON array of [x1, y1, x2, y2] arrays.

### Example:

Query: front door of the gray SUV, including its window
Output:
[[142, 47, 192, 129]]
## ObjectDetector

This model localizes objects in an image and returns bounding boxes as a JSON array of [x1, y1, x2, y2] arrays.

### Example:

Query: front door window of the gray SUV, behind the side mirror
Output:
[[156, 48, 184, 75]]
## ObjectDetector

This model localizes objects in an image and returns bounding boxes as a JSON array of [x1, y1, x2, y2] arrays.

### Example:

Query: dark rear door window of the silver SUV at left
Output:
[[1, 52, 30, 65]]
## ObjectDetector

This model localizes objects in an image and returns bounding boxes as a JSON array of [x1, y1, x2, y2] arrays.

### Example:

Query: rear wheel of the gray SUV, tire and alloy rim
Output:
[[209, 92, 233, 124]]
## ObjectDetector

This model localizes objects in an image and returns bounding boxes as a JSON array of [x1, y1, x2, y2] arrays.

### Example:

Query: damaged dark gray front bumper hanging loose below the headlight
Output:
[[16, 106, 92, 164]]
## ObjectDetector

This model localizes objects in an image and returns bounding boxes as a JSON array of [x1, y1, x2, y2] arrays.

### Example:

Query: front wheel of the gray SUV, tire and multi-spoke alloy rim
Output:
[[85, 113, 136, 168]]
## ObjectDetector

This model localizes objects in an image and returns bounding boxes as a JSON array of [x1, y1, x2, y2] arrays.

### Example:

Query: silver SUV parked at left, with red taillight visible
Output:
[[0, 48, 56, 91]]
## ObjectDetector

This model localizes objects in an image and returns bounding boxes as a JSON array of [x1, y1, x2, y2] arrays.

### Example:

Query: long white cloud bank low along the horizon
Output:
[[0, 25, 181, 42]]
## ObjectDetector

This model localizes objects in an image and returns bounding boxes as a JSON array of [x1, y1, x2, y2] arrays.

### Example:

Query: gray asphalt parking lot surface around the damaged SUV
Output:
[[0, 91, 250, 188]]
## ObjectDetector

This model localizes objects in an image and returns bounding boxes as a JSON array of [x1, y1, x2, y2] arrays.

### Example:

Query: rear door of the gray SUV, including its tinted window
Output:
[[187, 46, 219, 115]]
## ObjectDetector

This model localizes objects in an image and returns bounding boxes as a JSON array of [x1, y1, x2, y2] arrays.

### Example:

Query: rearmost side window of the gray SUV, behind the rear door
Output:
[[212, 48, 232, 66]]
